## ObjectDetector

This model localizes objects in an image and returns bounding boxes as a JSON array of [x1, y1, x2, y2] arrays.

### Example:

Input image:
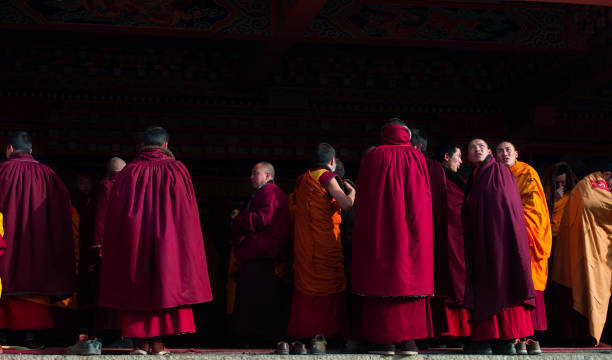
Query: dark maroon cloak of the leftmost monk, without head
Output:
[[0, 153, 75, 298]]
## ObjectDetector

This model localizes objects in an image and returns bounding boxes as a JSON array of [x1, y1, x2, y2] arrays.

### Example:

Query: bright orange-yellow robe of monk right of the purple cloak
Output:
[[510, 161, 552, 291]]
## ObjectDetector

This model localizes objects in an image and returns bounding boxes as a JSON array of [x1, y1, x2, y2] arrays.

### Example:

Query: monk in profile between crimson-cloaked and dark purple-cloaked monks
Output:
[[429, 143, 472, 338]]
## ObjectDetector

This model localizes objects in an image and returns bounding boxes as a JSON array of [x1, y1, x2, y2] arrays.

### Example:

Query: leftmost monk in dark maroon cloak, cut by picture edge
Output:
[[0, 131, 75, 347]]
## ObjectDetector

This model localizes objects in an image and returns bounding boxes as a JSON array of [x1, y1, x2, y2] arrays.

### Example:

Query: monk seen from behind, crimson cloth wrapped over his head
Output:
[[352, 118, 434, 355]]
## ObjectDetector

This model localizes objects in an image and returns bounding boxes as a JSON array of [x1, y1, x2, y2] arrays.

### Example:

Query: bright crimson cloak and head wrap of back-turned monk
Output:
[[352, 125, 434, 296]]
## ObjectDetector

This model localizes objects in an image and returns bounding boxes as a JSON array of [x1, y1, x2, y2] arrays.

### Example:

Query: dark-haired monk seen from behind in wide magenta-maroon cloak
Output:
[[99, 127, 212, 355]]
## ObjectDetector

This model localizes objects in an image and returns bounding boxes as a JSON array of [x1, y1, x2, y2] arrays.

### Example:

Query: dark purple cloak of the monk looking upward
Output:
[[462, 156, 536, 322]]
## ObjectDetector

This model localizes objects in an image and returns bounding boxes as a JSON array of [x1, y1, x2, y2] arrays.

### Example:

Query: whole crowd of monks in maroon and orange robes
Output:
[[0, 118, 612, 355]]
